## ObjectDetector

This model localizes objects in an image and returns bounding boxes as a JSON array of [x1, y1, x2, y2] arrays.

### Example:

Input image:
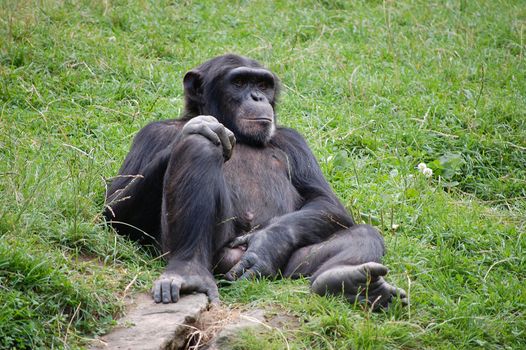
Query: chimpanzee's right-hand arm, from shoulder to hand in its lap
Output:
[[226, 128, 354, 279]]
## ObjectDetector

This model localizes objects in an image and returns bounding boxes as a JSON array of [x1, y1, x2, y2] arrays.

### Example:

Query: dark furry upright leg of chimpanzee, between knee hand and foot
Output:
[[161, 135, 233, 262]]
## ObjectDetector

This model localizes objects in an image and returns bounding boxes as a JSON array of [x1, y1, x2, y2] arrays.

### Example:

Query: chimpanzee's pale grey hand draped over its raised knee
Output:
[[181, 115, 236, 160]]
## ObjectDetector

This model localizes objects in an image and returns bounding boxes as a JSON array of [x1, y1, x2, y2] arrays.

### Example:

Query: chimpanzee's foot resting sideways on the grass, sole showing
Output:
[[311, 262, 407, 311]]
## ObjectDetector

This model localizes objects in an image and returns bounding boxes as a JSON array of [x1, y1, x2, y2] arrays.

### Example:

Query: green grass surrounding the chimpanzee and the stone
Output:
[[0, 0, 526, 349]]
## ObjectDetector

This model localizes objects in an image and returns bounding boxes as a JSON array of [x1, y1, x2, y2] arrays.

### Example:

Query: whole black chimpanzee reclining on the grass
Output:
[[104, 54, 406, 308]]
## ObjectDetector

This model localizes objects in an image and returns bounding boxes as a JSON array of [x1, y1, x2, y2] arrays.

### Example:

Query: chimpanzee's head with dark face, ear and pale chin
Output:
[[183, 55, 279, 146]]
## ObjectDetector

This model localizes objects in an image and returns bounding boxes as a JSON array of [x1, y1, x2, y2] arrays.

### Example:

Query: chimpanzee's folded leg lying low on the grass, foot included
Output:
[[284, 225, 406, 309]]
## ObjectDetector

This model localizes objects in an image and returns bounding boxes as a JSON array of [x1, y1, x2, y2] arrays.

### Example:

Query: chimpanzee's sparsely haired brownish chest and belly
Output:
[[224, 144, 301, 232]]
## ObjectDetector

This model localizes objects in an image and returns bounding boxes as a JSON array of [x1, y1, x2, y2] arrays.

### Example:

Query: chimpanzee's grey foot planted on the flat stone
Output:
[[152, 261, 219, 304]]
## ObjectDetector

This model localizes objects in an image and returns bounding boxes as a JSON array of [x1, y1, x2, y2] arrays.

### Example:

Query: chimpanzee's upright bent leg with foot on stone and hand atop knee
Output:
[[153, 117, 234, 303]]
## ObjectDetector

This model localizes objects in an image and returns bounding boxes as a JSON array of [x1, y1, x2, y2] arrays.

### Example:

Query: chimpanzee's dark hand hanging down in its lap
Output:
[[225, 230, 291, 281]]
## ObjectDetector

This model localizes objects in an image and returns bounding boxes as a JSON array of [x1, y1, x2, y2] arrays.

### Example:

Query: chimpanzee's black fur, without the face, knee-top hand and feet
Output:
[[104, 55, 400, 306]]
